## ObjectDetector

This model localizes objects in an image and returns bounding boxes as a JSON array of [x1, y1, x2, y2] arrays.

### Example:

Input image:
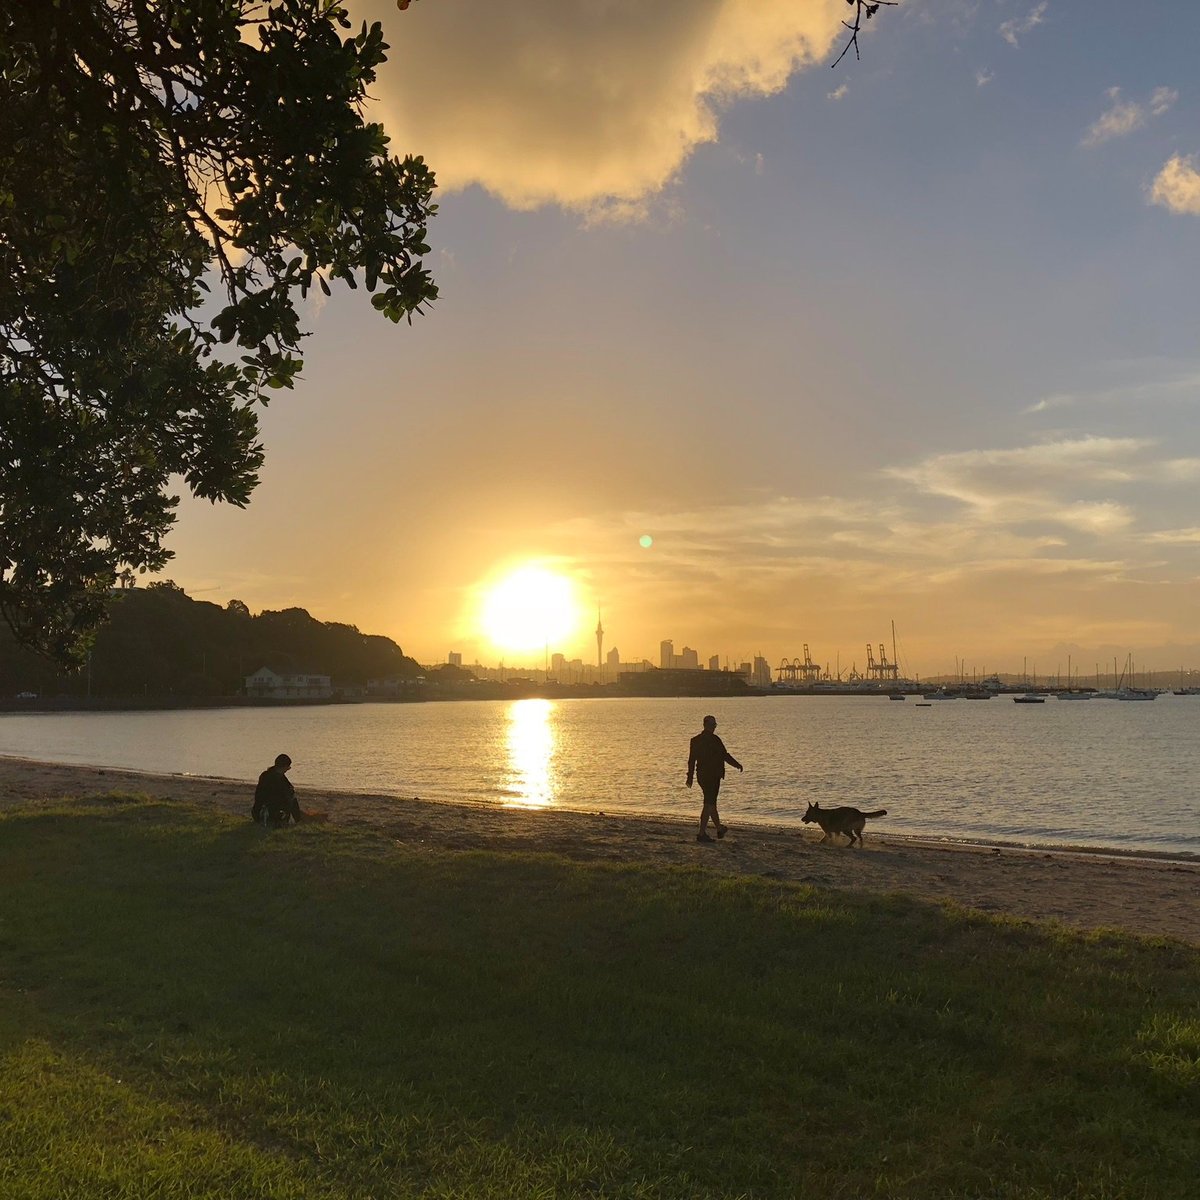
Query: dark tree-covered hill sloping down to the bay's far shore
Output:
[[0, 581, 421, 700]]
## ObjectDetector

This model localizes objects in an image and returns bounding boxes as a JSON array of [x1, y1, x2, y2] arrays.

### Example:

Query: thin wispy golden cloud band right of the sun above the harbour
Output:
[[446, 427, 1200, 665]]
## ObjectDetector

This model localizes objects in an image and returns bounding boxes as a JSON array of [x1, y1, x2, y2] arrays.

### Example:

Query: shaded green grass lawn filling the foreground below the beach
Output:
[[0, 796, 1200, 1200]]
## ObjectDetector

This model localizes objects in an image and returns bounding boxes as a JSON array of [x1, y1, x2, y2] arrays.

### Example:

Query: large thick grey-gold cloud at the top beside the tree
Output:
[[352, 0, 845, 215]]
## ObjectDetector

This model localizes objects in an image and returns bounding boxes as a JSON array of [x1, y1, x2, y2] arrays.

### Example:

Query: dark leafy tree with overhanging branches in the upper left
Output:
[[0, 0, 437, 664]]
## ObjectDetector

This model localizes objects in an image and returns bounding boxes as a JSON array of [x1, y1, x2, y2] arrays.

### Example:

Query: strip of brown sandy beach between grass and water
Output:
[[0, 757, 1200, 944]]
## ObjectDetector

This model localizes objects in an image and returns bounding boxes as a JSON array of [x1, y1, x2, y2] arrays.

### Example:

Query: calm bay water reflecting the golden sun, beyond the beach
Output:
[[0, 696, 1200, 854]]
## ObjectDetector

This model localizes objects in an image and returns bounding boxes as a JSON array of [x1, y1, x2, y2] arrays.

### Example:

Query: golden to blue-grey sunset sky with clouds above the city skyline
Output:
[[167, 0, 1200, 677]]
